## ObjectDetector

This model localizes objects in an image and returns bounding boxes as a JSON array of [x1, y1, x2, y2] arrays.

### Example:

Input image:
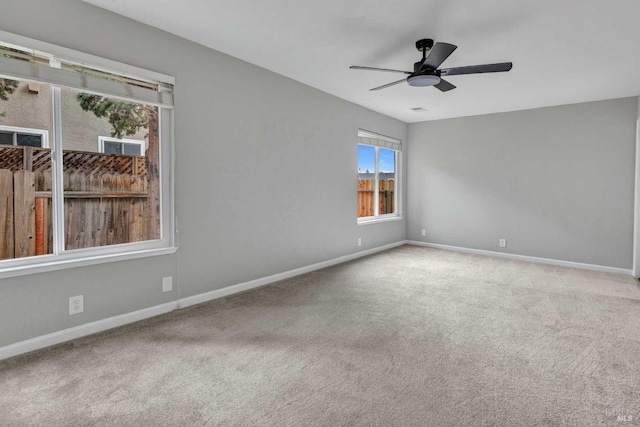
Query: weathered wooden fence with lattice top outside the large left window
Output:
[[0, 147, 148, 259]]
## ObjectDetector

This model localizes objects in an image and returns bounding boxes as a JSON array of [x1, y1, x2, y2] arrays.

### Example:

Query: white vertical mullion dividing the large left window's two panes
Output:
[[51, 87, 65, 255]]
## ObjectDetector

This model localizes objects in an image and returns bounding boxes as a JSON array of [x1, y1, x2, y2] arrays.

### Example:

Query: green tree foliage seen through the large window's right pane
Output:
[[77, 92, 155, 138]]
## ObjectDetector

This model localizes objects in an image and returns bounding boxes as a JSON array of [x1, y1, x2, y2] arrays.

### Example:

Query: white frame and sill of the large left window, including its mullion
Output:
[[0, 30, 178, 279]]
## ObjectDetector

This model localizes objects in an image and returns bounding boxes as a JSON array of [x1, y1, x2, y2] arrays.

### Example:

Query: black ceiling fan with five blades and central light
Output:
[[349, 39, 513, 92]]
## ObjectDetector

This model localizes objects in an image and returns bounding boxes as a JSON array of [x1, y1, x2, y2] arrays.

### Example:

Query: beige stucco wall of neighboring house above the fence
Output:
[[0, 82, 147, 152]]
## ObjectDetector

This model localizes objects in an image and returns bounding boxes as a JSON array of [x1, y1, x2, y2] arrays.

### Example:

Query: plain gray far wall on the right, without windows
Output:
[[407, 98, 638, 269]]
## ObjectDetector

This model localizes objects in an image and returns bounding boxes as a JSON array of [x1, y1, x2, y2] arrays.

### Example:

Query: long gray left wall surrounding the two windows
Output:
[[0, 0, 407, 346]]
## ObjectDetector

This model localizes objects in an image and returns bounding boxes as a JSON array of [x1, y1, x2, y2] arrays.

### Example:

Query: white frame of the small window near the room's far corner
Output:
[[356, 129, 402, 225]]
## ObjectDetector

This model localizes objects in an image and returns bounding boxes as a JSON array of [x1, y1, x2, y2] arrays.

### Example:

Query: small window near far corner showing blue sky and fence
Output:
[[357, 130, 402, 222]]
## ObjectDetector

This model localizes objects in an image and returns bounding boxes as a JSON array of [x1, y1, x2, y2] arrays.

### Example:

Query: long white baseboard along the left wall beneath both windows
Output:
[[0, 241, 406, 360]]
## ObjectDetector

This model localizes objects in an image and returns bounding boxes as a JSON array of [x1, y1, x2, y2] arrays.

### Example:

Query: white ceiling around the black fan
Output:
[[85, 0, 640, 122]]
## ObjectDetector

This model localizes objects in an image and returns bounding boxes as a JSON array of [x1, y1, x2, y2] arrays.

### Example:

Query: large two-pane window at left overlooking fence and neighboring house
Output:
[[0, 36, 174, 277]]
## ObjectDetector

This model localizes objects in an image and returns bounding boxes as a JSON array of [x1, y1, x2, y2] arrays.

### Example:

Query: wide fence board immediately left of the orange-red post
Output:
[[13, 170, 36, 258]]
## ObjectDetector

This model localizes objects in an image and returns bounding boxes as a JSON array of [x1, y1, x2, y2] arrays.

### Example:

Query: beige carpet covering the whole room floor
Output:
[[0, 246, 640, 426]]
